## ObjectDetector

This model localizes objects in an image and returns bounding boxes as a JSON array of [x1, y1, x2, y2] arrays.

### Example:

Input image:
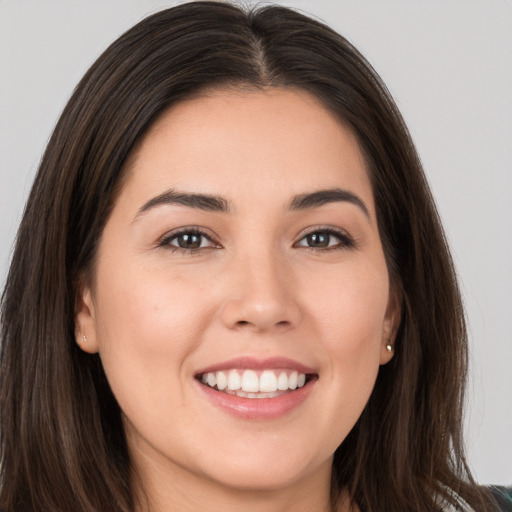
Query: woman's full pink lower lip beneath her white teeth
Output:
[[197, 379, 316, 420]]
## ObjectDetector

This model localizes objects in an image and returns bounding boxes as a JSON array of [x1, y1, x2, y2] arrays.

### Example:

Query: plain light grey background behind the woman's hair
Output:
[[0, 0, 512, 485]]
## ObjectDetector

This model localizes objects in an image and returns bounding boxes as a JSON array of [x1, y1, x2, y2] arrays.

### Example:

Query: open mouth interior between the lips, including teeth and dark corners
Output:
[[196, 369, 316, 399]]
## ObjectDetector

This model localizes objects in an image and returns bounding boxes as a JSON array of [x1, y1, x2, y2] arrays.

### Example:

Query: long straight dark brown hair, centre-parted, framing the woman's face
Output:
[[0, 2, 496, 512]]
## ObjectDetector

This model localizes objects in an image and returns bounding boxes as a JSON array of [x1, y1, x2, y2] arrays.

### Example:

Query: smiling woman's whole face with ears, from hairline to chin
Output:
[[77, 89, 397, 500]]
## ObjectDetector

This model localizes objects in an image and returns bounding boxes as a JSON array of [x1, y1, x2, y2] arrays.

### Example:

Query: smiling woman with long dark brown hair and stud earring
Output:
[[0, 2, 504, 512]]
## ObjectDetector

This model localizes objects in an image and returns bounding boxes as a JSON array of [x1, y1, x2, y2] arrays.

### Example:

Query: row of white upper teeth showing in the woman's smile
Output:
[[201, 369, 306, 393]]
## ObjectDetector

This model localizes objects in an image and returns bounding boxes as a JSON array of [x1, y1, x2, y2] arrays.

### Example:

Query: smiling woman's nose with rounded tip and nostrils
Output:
[[222, 251, 301, 332]]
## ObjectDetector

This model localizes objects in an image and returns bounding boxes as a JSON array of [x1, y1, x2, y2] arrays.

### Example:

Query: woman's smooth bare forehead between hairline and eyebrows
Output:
[[125, 89, 373, 214]]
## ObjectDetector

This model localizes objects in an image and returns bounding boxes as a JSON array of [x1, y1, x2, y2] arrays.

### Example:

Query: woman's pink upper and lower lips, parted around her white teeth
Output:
[[196, 357, 317, 421]]
